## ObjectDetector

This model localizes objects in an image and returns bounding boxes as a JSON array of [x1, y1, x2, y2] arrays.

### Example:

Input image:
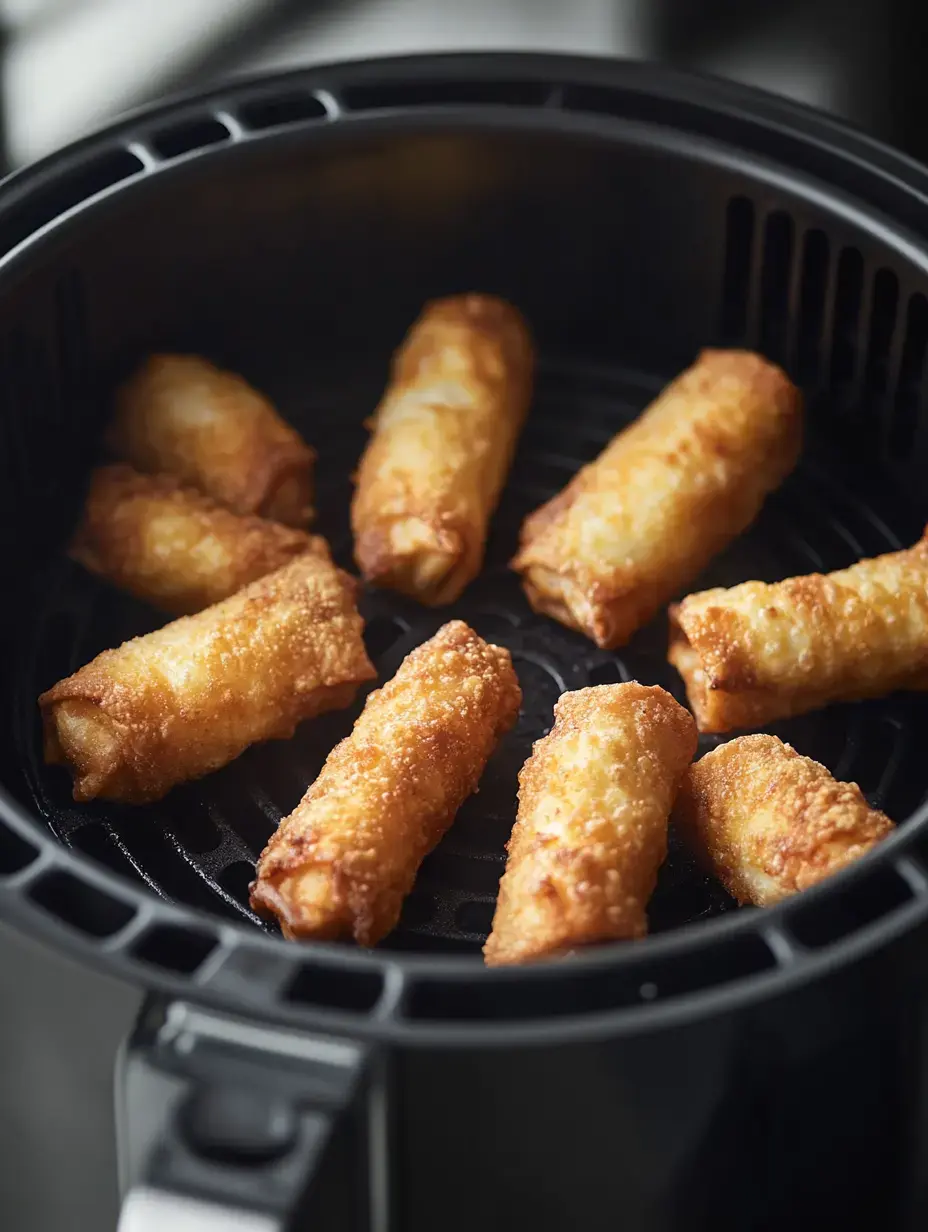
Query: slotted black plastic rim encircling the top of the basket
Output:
[[0, 54, 928, 1046]]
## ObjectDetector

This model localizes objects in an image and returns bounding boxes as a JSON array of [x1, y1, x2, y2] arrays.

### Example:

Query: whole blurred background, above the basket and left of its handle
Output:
[[0, 0, 928, 1232]]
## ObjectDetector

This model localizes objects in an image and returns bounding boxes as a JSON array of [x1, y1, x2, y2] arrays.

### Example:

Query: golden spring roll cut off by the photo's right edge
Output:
[[668, 522, 928, 732]]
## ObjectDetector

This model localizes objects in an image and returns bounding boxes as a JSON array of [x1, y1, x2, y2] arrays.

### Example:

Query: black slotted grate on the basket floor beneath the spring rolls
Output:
[[16, 365, 928, 954]]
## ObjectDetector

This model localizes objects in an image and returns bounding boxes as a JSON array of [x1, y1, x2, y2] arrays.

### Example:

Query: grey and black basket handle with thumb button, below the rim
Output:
[[117, 1000, 380, 1232]]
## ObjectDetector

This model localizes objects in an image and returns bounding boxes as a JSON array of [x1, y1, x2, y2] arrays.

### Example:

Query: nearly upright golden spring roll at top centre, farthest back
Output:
[[351, 294, 532, 605]]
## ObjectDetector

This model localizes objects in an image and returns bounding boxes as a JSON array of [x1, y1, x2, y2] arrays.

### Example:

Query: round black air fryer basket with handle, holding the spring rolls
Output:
[[0, 55, 928, 1232]]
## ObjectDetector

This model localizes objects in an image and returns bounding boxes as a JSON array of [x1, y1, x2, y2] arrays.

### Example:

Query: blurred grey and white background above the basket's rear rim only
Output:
[[0, 0, 928, 166]]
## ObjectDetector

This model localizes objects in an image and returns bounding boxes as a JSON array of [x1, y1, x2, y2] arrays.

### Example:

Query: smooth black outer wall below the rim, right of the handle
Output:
[[396, 971, 926, 1232]]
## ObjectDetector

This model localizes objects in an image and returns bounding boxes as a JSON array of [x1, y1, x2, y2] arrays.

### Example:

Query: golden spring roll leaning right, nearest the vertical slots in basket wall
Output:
[[513, 351, 802, 647]]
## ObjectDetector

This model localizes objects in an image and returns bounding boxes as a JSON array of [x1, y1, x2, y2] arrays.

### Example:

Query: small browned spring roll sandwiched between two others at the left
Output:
[[69, 463, 328, 616]]
